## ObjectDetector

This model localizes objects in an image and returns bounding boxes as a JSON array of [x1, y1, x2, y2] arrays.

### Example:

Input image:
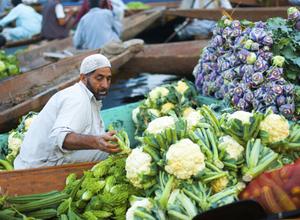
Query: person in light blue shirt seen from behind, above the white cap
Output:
[[73, 0, 122, 49]]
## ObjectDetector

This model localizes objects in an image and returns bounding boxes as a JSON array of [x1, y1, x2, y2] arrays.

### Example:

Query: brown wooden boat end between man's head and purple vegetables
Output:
[[120, 40, 208, 76]]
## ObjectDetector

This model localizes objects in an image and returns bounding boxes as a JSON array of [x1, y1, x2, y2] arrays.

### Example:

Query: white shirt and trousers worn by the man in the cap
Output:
[[14, 82, 108, 169]]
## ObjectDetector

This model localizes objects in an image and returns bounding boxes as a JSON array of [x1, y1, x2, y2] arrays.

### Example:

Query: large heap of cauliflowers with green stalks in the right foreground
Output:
[[126, 81, 300, 219]]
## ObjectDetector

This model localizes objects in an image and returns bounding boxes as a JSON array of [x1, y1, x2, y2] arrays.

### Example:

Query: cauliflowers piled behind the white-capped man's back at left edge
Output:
[[0, 112, 37, 170]]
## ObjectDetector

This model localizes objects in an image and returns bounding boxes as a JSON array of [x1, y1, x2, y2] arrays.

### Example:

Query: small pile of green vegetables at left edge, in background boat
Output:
[[0, 50, 20, 79]]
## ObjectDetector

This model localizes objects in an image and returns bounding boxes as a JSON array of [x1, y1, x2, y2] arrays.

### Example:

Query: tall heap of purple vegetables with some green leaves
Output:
[[194, 8, 300, 119]]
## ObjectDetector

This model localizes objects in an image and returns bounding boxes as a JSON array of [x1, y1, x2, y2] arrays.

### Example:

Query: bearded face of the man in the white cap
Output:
[[80, 67, 111, 100]]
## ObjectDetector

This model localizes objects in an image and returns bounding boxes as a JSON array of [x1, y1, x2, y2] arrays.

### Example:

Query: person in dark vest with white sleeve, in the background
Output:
[[42, 0, 74, 40]]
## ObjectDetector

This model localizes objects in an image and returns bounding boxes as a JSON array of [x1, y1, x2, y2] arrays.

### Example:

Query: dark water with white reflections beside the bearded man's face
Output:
[[103, 73, 181, 109]]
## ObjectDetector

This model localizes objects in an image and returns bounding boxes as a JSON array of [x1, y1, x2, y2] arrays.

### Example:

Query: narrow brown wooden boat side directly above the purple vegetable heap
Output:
[[164, 7, 287, 21]]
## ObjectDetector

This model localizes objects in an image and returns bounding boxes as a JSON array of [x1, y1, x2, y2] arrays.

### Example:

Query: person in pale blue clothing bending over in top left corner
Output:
[[0, 0, 42, 43]]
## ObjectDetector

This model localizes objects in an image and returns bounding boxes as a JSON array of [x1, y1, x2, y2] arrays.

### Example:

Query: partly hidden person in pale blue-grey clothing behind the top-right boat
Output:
[[177, 0, 232, 39]]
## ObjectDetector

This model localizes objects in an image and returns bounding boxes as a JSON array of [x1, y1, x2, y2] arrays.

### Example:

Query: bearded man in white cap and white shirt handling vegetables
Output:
[[14, 54, 120, 169]]
